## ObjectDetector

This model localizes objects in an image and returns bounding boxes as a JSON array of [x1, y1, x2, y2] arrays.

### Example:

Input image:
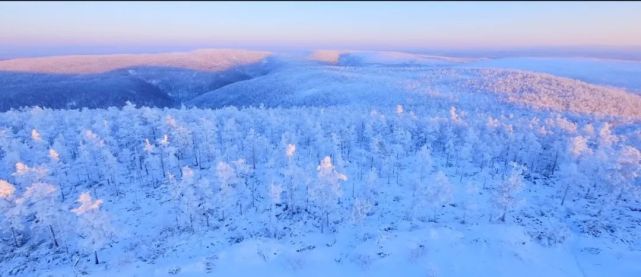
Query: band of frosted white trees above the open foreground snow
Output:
[[0, 104, 641, 263]]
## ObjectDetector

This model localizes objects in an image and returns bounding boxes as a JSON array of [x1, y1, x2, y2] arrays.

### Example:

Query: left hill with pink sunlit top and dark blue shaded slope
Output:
[[0, 50, 273, 111]]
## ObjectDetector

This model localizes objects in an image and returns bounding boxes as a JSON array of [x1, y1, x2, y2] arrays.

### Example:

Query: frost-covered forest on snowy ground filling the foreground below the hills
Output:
[[0, 92, 641, 276]]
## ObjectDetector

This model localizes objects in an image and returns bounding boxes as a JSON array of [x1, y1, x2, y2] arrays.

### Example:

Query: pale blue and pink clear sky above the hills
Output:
[[0, 1, 641, 56]]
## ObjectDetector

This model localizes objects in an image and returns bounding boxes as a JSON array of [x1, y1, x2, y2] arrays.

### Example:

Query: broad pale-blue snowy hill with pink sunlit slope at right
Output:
[[188, 65, 641, 119]]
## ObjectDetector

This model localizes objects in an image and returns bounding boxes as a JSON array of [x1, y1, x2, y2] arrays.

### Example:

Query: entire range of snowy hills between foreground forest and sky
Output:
[[0, 49, 641, 118]]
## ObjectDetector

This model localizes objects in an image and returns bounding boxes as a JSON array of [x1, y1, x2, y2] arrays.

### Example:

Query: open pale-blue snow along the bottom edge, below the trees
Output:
[[37, 223, 641, 277]]
